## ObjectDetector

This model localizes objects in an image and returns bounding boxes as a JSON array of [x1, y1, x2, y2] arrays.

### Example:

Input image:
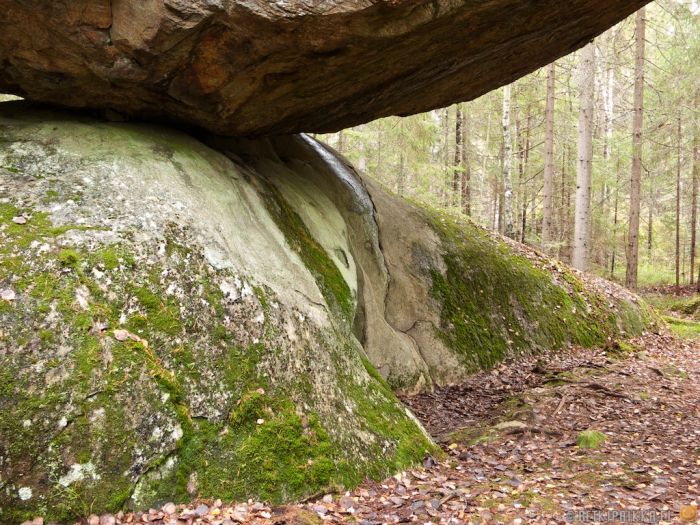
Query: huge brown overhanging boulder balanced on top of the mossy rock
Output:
[[0, 0, 647, 135]]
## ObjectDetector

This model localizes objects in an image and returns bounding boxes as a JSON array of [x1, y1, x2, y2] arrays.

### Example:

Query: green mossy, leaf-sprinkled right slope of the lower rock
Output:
[[427, 212, 648, 371]]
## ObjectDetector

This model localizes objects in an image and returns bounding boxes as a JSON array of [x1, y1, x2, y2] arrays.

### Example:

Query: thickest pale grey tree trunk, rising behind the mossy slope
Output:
[[571, 42, 595, 271]]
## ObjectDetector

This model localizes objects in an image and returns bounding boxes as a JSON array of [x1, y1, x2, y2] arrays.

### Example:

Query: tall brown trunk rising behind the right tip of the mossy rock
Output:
[[625, 8, 645, 290]]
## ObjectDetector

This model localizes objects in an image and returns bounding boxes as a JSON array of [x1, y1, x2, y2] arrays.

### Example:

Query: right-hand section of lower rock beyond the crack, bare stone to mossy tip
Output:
[[366, 181, 657, 390]]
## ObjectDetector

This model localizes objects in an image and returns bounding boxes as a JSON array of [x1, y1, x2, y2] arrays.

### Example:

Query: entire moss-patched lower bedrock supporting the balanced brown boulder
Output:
[[0, 102, 650, 523]]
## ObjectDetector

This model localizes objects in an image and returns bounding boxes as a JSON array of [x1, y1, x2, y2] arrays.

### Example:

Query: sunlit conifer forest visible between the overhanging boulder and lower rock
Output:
[[319, 0, 700, 288]]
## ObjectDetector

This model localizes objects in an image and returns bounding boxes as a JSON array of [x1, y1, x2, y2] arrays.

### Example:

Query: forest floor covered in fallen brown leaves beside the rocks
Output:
[[64, 320, 700, 525]]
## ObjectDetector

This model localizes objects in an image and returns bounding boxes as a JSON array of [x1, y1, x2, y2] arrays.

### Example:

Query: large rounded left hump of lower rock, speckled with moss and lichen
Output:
[[0, 106, 434, 523]]
